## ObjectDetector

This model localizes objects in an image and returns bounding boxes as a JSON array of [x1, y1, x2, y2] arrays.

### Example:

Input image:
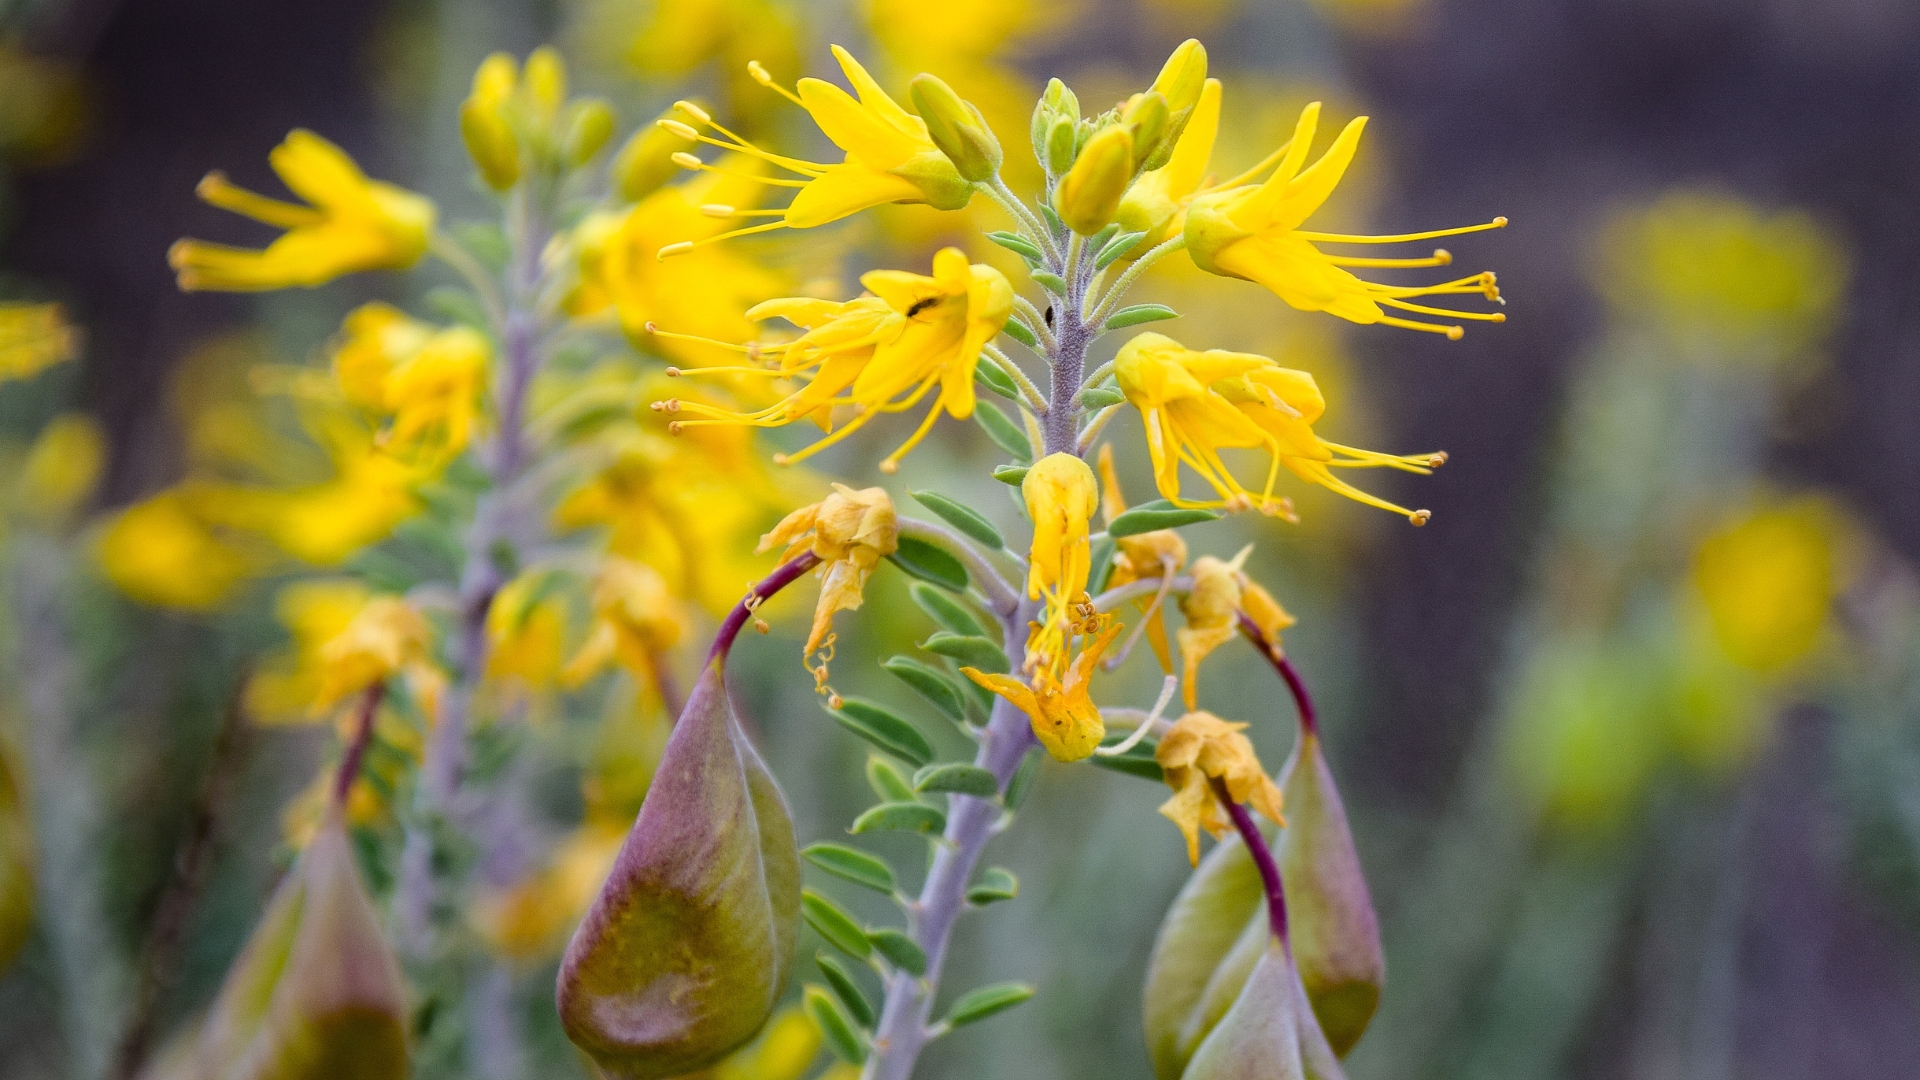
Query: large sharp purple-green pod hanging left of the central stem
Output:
[[557, 663, 801, 1080]]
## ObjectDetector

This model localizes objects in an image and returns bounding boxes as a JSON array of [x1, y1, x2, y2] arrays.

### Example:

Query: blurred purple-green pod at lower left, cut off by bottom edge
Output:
[[194, 813, 407, 1080]]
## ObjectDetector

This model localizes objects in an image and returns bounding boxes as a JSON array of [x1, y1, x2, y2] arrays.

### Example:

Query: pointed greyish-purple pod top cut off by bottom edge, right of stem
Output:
[[1181, 934, 1346, 1080]]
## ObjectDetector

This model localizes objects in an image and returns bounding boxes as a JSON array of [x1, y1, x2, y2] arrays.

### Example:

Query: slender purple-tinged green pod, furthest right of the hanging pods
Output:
[[1277, 730, 1386, 1057]]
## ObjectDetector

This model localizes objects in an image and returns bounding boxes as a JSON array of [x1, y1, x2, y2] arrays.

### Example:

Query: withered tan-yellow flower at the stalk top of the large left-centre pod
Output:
[[758, 484, 900, 678]]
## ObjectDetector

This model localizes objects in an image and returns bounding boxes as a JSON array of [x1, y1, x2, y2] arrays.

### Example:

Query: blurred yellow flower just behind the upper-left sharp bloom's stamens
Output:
[[568, 156, 781, 365]]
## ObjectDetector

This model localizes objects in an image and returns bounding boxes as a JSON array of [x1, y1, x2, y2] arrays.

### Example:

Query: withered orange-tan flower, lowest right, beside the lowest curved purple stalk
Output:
[[1154, 713, 1286, 867]]
